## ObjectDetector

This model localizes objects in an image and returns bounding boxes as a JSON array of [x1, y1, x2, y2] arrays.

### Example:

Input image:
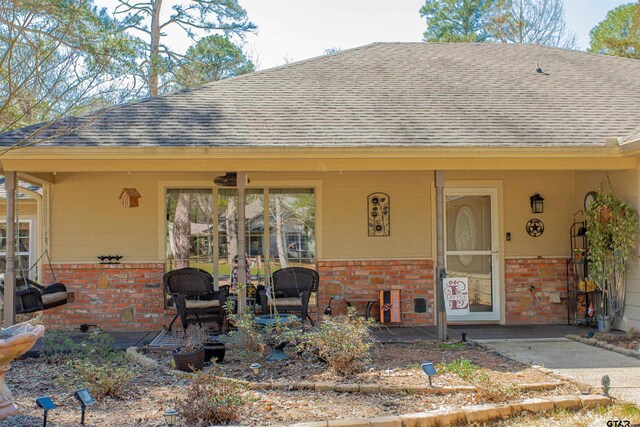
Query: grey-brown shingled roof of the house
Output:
[[0, 43, 640, 147]]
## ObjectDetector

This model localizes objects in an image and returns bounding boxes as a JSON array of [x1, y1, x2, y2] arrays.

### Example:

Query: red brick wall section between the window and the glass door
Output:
[[318, 260, 435, 325]]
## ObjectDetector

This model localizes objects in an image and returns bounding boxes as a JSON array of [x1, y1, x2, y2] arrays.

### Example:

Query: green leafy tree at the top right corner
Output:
[[589, 2, 640, 59]]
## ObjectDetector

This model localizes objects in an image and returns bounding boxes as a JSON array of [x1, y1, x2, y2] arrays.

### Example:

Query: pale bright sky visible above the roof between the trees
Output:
[[96, 0, 630, 69]]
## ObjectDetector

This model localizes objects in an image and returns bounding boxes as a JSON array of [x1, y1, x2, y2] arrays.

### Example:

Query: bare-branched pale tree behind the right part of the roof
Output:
[[490, 0, 576, 49]]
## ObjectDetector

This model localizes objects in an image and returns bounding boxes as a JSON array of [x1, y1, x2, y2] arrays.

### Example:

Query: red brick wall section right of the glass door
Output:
[[505, 258, 567, 325]]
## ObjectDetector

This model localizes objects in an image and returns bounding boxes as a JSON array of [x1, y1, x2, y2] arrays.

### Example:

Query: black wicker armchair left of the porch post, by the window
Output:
[[162, 268, 228, 331]]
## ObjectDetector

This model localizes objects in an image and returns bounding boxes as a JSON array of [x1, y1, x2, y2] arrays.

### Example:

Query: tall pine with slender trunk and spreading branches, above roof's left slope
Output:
[[115, 0, 255, 96]]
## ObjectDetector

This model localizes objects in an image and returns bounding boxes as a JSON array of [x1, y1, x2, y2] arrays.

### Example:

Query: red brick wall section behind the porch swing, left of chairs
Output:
[[44, 263, 175, 331]]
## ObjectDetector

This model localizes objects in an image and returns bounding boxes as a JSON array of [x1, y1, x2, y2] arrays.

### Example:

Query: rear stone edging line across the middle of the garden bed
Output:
[[125, 347, 566, 395]]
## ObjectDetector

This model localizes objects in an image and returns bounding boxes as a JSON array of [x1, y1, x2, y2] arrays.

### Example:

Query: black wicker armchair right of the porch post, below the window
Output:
[[260, 267, 320, 325]]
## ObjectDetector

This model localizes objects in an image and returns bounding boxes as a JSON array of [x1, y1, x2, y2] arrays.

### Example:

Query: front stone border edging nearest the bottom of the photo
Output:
[[290, 395, 611, 427]]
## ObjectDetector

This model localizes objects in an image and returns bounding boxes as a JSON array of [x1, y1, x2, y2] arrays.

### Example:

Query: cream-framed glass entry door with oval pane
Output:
[[445, 188, 500, 321]]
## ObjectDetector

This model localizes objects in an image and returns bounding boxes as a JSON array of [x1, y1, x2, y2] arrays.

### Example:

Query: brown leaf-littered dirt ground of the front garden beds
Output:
[[0, 343, 577, 427]]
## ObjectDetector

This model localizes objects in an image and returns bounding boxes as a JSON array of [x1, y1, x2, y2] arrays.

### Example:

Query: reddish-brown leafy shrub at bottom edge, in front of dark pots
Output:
[[176, 367, 248, 426]]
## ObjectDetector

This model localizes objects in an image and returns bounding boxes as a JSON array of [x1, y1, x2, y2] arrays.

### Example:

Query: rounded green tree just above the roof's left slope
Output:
[[175, 34, 255, 88]]
